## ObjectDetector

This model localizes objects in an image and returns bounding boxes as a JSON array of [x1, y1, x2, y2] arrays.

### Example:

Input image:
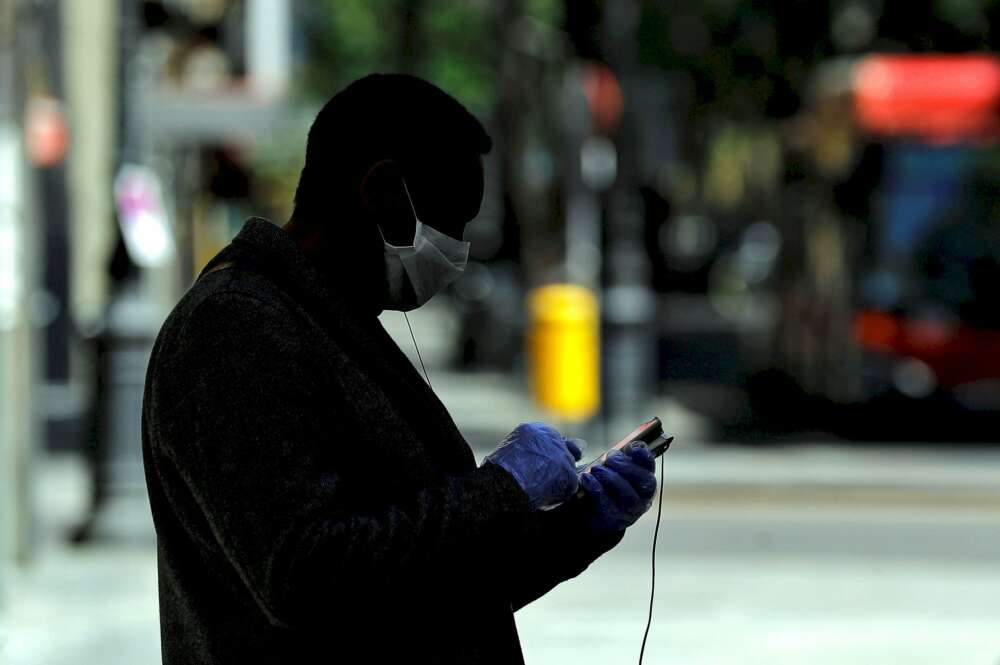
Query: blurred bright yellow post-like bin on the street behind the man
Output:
[[526, 284, 601, 422]]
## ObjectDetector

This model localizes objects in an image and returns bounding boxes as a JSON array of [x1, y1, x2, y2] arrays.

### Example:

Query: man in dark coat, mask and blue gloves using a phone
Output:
[[143, 75, 656, 665]]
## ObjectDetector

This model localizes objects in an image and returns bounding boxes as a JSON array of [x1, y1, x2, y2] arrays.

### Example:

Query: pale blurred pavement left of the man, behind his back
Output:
[[0, 454, 160, 665]]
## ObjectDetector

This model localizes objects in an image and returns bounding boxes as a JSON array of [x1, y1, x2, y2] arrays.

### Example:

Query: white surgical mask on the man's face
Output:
[[379, 180, 469, 312]]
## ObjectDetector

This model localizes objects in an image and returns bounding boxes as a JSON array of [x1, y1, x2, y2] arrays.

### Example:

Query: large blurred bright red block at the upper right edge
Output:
[[854, 55, 1000, 143]]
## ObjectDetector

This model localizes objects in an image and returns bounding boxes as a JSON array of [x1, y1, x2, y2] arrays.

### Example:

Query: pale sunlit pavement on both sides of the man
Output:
[[7, 444, 1000, 665]]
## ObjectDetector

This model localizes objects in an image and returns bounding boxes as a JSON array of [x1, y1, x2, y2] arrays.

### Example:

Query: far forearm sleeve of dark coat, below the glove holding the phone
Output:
[[508, 499, 624, 610]]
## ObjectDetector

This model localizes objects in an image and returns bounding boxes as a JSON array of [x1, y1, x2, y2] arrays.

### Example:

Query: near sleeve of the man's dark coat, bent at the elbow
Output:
[[164, 293, 530, 626]]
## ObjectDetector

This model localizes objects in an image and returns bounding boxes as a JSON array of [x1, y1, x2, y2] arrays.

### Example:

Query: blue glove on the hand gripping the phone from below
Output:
[[580, 441, 656, 531]]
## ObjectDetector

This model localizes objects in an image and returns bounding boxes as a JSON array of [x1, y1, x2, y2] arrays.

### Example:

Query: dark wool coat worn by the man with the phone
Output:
[[142, 219, 621, 665]]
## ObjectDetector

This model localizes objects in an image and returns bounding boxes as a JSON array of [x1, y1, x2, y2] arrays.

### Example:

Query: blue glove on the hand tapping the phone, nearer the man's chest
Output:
[[486, 423, 583, 509]]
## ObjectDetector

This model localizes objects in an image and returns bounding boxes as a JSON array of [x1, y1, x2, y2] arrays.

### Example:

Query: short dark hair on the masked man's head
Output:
[[295, 74, 493, 214]]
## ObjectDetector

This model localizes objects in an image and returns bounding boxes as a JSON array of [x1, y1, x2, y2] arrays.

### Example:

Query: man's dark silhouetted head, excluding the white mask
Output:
[[295, 74, 492, 246]]
